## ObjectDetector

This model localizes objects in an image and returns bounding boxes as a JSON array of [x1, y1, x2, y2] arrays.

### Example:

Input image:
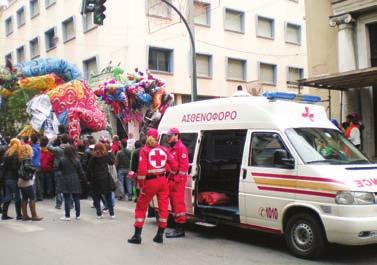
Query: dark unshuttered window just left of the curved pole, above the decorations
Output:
[[148, 47, 173, 73]]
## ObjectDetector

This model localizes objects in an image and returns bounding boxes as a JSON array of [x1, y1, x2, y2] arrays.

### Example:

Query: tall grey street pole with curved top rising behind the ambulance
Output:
[[161, 0, 198, 101]]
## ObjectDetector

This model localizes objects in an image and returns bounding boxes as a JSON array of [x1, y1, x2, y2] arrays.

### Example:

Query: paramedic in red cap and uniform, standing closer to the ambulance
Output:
[[166, 128, 189, 238]]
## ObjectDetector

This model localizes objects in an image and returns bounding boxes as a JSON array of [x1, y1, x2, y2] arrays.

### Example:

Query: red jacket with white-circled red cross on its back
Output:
[[137, 145, 178, 187]]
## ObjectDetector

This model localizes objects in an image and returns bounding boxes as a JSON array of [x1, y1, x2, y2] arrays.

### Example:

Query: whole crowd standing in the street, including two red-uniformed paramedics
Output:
[[0, 128, 189, 244]]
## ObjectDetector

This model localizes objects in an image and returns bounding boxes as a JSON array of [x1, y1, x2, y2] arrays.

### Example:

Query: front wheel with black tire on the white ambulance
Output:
[[284, 213, 328, 259]]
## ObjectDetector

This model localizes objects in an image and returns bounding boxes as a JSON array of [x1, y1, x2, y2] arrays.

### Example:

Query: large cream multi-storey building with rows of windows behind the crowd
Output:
[[0, 0, 307, 103]]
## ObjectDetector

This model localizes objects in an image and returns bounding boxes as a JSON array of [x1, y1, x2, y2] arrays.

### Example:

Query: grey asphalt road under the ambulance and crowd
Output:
[[0, 200, 377, 265]]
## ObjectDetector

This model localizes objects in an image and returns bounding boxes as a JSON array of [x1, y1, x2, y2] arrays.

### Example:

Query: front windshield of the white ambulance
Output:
[[286, 128, 370, 164]]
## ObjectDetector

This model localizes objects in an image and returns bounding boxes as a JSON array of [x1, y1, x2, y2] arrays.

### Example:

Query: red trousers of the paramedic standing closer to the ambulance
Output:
[[169, 175, 187, 224]]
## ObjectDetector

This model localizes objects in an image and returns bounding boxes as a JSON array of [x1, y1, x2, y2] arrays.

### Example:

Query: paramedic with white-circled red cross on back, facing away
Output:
[[128, 129, 177, 244]]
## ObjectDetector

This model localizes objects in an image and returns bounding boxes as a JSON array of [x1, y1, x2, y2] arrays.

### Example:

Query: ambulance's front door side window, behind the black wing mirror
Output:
[[249, 132, 292, 168]]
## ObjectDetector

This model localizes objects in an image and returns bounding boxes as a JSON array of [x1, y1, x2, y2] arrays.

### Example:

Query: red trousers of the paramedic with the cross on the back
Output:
[[135, 177, 169, 228]]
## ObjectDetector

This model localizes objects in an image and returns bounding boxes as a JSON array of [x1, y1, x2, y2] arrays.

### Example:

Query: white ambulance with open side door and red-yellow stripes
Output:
[[159, 93, 377, 258]]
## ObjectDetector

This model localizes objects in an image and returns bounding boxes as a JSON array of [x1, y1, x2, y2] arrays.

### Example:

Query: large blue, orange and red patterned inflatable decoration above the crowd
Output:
[[0, 58, 106, 139]]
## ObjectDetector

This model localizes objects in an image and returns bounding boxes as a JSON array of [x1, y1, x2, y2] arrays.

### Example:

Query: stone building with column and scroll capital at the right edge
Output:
[[329, 0, 377, 157]]
